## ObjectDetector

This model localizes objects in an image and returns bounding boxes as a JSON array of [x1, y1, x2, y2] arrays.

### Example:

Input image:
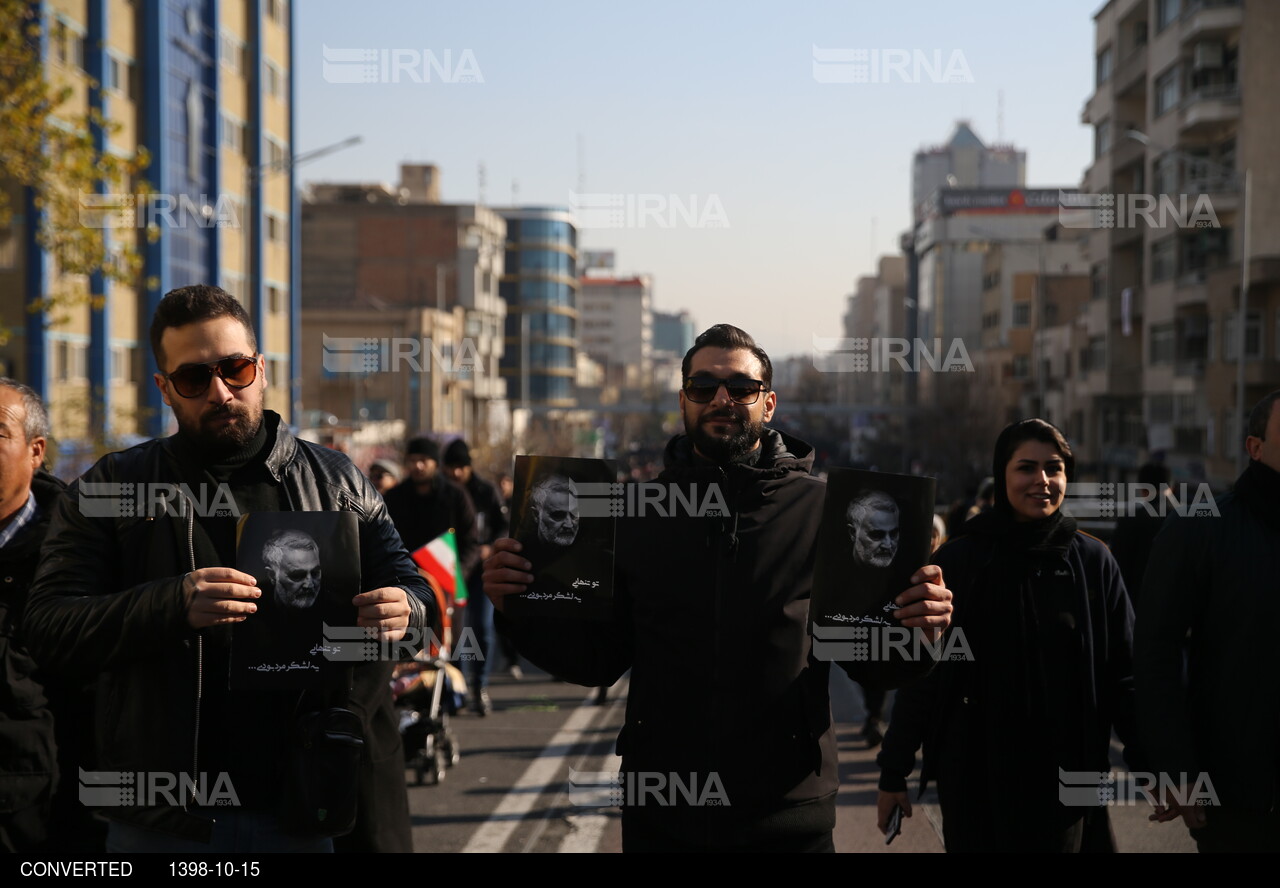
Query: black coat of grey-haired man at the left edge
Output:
[[0, 470, 67, 844]]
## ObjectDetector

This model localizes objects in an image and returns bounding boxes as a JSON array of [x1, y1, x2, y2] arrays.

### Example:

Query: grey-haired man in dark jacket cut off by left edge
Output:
[[0, 377, 67, 853]]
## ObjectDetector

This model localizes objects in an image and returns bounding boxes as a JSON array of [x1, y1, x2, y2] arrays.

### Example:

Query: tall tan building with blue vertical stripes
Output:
[[0, 0, 300, 443]]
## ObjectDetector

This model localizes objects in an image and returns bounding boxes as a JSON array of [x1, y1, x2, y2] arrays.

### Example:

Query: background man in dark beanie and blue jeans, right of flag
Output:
[[444, 438, 507, 715]]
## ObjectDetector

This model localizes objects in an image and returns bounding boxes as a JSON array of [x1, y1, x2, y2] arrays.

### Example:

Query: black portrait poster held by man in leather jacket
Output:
[[230, 512, 361, 688]]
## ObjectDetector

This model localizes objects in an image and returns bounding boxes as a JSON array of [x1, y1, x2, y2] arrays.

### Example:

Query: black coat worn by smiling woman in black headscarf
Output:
[[877, 531, 1137, 851]]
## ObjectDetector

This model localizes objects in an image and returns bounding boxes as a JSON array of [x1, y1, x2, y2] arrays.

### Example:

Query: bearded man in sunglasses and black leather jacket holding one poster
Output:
[[28, 285, 435, 852]]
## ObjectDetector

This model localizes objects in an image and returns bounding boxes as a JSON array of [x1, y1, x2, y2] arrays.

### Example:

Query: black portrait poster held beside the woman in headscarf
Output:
[[809, 468, 937, 628]]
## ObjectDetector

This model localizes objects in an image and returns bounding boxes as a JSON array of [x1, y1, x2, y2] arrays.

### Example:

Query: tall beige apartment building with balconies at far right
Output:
[[1076, 0, 1280, 485]]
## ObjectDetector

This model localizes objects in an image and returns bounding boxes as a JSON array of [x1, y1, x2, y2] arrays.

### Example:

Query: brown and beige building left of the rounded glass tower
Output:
[[302, 164, 509, 439]]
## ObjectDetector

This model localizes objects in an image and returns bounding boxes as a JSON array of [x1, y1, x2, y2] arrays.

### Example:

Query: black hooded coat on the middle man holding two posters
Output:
[[500, 430, 933, 848]]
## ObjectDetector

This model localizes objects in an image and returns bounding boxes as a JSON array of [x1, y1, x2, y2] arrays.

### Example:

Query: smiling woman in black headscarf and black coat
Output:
[[877, 420, 1133, 852]]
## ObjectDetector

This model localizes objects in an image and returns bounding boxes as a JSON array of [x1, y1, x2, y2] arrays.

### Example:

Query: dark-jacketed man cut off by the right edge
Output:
[[1134, 389, 1280, 851]]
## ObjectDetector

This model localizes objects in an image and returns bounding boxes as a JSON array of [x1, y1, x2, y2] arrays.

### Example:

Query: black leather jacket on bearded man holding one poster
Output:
[[26, 411, 435, 841]]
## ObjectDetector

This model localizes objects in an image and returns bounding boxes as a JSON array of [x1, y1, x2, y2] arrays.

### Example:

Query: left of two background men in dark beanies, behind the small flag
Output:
[[383, 438, 480, 611]]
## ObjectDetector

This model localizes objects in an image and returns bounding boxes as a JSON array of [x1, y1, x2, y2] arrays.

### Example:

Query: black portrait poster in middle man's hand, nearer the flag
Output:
[[506, 457, 623, 619]]
